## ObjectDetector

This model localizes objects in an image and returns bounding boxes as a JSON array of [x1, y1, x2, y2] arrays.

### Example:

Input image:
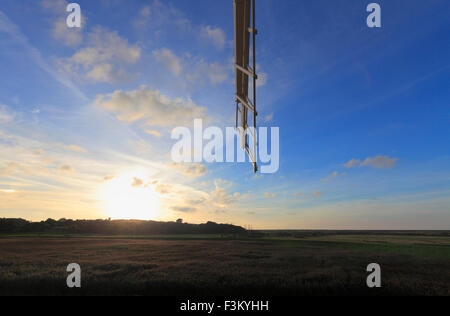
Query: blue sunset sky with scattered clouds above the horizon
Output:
[[0, 0, 450, 230]]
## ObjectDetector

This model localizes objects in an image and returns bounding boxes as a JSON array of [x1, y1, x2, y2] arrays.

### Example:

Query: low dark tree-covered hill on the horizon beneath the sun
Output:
[[0, 218, 246, 235]]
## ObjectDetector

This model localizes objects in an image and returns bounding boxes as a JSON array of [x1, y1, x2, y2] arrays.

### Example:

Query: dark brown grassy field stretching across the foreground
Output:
[[0, 232, 450, 296]]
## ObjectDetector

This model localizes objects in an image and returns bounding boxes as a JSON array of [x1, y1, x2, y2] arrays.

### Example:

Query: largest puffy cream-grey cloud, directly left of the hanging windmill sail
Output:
[[95, 86, 205, 127]]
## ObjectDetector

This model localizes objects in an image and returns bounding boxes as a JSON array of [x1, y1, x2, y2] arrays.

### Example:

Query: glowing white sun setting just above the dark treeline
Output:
[[99, 172, 161, 220]]
